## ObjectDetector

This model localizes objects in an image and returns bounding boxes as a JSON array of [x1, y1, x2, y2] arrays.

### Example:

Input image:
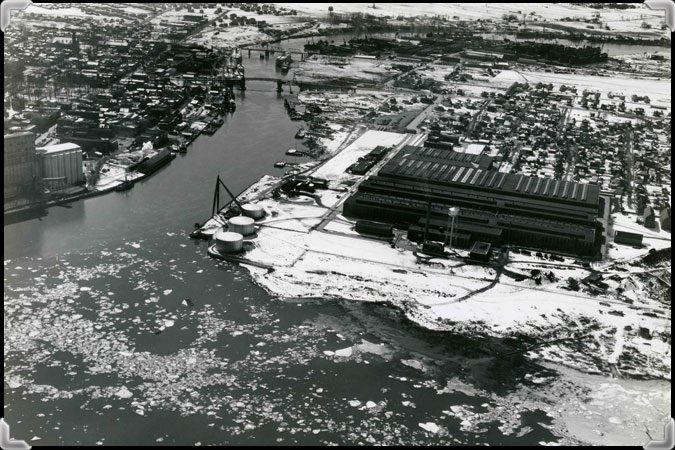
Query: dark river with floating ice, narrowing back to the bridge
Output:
[[4, 42, 664, 445]]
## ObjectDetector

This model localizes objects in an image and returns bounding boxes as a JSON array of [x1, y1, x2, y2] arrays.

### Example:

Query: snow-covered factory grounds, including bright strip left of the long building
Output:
[[197, 125, 670, 379]]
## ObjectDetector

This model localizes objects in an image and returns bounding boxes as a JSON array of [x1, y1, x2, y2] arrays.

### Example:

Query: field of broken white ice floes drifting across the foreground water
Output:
[[5, 248, 665, 445]]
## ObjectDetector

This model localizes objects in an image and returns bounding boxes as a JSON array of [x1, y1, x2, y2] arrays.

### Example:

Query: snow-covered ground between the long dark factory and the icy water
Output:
[[234, 207, 670, 378]]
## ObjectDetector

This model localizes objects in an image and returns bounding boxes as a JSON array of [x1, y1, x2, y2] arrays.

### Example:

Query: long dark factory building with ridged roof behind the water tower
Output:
[[344, 146, 603, 257]]
